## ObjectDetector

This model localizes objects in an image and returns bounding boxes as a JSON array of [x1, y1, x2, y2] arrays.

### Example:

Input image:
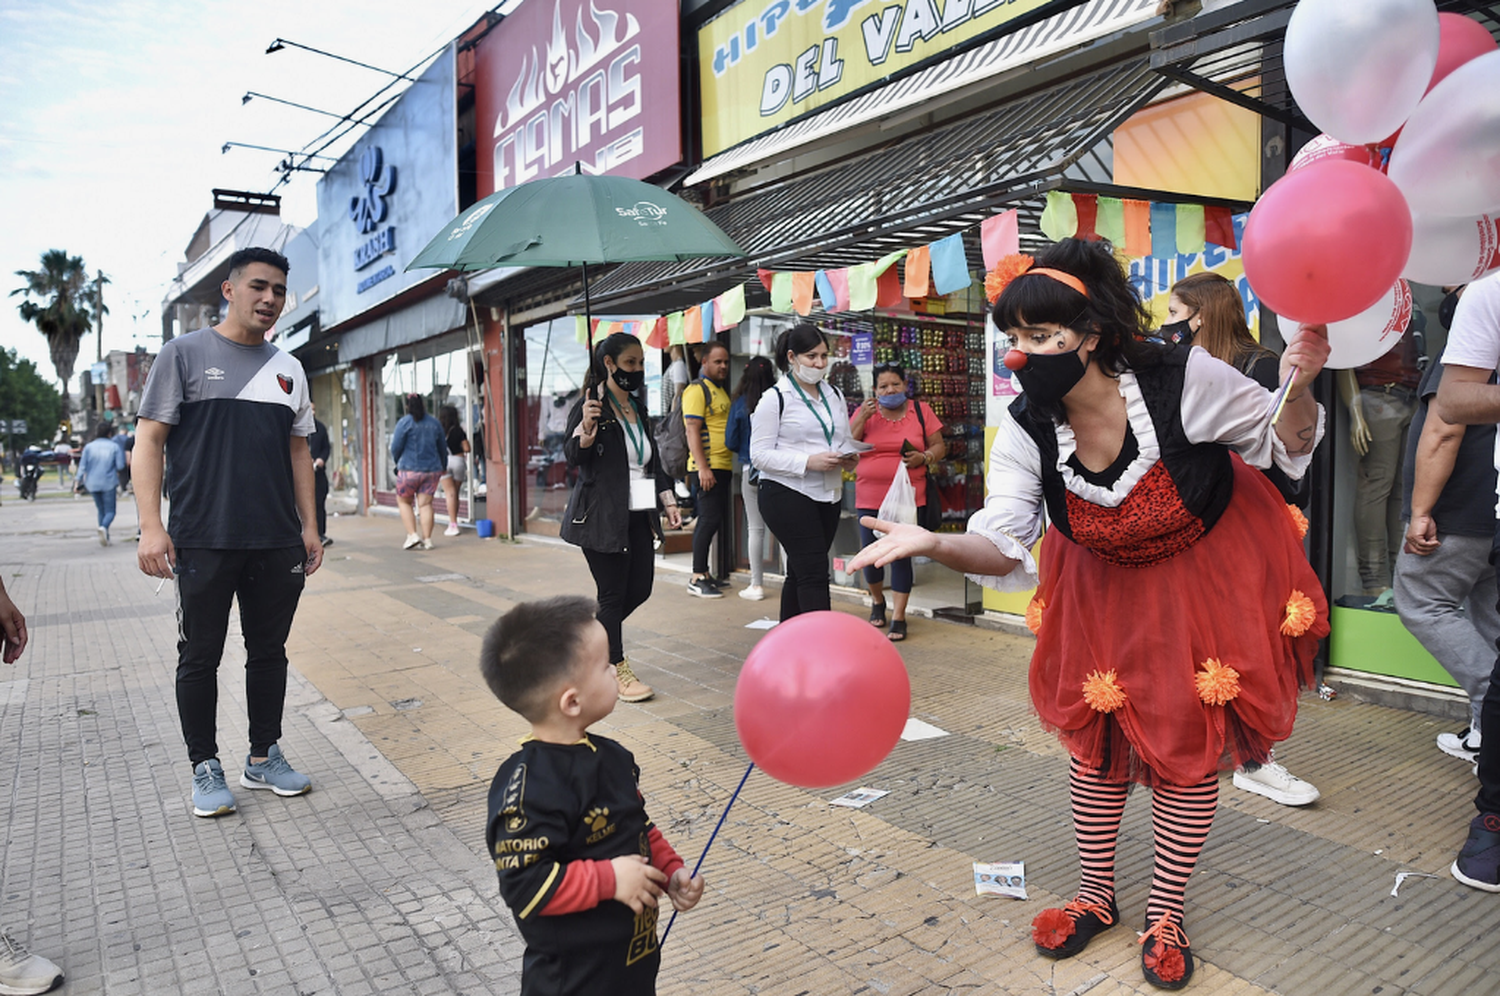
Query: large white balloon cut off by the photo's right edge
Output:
[[1388, 51, 1500, 218]]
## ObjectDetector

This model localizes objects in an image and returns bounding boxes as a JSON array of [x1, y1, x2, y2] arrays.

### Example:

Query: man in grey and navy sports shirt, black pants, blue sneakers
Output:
[[134, 248, 323, 816]]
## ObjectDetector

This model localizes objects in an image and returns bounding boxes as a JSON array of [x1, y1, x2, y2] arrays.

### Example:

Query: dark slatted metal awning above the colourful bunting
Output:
[[591, 59, 1169, 314]]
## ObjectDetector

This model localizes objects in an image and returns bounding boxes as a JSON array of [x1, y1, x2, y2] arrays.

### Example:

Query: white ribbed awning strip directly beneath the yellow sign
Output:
[[684, 0, 1158, 186]]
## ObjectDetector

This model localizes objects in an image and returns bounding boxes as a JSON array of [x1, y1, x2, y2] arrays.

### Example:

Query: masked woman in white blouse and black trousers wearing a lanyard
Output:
[[750, 323, 860, 623]]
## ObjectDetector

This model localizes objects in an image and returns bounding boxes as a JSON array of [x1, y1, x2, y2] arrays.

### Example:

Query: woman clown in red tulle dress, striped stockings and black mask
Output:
[[851, 239, 1329, 989]]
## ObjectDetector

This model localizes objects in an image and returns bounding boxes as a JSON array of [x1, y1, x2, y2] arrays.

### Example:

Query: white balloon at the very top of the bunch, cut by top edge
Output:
[[1281, 0, 1439, 146]]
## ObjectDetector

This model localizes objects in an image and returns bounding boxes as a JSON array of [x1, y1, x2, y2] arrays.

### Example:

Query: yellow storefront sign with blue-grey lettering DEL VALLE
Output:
[[698, 0, 1047, 156]]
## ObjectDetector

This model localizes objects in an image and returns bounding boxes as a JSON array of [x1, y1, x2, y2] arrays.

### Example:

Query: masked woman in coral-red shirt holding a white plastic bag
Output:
[[849, 363, 947, 642]]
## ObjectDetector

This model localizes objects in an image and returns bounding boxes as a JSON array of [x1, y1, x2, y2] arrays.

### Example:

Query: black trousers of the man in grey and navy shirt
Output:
[[177, 545, 308, 767]]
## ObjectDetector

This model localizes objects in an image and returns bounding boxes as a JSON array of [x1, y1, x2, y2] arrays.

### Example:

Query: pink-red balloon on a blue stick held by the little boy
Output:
[[735, 612, 912, 789]]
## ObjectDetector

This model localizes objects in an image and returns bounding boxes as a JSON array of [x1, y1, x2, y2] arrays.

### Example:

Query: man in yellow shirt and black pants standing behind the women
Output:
[[683, 342, 735, 599]]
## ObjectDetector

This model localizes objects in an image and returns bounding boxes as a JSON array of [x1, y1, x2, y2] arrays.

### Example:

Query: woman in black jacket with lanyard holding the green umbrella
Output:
[[561, 332, 683, 702]]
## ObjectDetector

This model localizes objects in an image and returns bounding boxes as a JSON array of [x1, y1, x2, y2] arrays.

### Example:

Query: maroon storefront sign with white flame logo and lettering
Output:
[[476, 0, 681, 194]]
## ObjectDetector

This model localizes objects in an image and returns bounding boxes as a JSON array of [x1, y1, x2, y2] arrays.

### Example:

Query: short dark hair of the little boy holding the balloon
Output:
[[479, 596, 599, 723]]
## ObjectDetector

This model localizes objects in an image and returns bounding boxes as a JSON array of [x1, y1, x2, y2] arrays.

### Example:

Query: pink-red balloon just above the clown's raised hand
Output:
[[1244, 159, 1412, 324]]
